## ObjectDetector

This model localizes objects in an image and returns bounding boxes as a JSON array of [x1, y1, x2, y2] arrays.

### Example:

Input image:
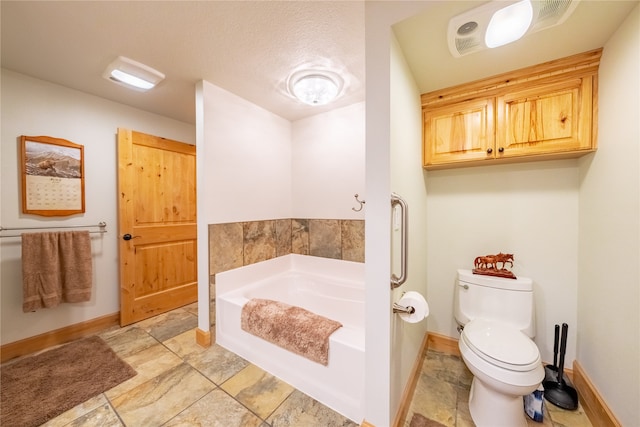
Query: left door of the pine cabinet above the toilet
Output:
[[423, 98, 495, 168]]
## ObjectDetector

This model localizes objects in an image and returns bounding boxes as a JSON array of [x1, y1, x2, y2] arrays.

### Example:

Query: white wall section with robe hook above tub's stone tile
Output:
[[291, 102, 367, 219]]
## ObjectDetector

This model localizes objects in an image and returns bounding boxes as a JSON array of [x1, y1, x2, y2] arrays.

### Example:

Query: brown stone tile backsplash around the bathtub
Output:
[[209, 219, 364, 326]]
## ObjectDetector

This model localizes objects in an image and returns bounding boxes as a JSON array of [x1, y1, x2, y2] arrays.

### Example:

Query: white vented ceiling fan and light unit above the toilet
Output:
[[447, 0, 580, 57]]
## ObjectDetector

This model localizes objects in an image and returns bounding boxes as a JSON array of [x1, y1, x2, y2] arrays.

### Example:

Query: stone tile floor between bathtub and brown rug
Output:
[[37, 304, 357, 427]]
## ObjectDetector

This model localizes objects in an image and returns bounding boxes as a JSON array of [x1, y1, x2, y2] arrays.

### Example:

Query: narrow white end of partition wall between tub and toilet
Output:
[[365, 2, 425, 427]]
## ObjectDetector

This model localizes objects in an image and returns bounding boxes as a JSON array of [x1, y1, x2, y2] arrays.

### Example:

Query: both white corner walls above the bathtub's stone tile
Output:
[[199, 82, 366, 224]]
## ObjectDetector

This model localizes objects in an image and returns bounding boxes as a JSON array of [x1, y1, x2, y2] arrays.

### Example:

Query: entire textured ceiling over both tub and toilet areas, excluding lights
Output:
[[0, 0, 638, 123]]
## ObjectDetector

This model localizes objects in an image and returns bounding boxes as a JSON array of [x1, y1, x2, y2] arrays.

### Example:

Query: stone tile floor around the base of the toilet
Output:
[[404, 351, 591, 427]]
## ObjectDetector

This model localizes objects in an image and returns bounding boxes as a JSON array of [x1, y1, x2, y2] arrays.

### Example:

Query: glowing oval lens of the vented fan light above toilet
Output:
[[484, 0, 533, 48]]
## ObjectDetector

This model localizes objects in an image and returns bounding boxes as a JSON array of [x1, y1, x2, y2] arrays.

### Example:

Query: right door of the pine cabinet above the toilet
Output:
[[496, 77, 593, 157]]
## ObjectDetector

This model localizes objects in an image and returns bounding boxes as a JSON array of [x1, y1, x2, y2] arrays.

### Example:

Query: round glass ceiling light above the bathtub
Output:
[[288, 70, 344, 105]]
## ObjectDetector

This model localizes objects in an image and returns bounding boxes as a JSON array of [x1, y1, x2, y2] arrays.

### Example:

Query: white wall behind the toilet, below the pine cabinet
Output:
[[427, 160, 579, 366]]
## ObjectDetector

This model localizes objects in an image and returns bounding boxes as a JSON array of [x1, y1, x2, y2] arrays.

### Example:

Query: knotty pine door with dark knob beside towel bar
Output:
[[118, 129, 198, 326]]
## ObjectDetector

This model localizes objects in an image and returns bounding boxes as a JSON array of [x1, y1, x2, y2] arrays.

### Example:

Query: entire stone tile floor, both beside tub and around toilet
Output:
[[10, 304, 591, 427]]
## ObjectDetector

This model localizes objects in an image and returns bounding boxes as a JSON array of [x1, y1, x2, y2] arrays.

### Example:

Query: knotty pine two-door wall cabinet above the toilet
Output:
[[422, 49, 602, 169]]
